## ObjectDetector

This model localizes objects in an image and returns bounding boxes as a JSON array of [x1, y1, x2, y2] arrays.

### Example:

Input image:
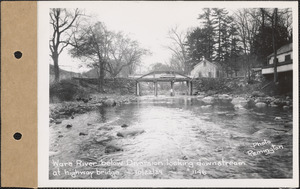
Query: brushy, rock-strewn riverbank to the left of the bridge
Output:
[[49, 79, 136, 124]]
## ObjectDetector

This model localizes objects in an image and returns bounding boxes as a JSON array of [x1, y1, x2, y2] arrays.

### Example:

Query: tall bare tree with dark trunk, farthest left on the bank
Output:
[[49, 8, 81, 82]]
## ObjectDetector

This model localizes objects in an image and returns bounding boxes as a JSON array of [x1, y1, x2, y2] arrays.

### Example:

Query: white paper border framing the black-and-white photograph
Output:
[[37, 1, 299, 187]]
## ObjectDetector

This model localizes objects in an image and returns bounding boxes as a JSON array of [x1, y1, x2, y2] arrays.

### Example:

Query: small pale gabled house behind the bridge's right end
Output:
[[191, 58, 222, 78]]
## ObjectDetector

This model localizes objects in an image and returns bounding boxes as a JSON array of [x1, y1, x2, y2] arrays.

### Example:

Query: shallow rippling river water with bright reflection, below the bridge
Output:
[[49, 96, 292, 179]]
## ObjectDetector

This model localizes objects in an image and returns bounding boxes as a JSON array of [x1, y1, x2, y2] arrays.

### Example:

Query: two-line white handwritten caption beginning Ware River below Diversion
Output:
[[51, 158, 246, 178]]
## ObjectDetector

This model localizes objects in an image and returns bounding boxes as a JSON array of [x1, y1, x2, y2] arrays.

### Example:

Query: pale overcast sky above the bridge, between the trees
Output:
[[60, 2, 207, 72]]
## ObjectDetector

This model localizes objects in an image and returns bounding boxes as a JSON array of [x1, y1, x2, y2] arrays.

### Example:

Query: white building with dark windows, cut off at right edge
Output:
[[262, 43, 293, 75]]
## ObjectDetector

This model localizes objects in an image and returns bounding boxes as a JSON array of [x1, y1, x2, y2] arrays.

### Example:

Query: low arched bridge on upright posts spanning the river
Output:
[[136, 71, 193, 96]]
